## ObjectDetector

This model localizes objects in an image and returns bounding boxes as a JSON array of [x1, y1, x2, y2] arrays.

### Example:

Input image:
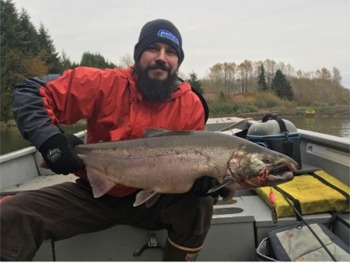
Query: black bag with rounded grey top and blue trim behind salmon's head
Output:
[[246, 114, 302, 169]]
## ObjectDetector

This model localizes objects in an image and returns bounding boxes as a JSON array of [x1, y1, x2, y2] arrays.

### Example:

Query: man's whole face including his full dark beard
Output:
[[135, 42, 179, 102]]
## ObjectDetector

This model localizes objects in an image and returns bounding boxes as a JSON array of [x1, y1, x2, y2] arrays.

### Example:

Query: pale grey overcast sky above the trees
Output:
[[13, 0, 350, 88]]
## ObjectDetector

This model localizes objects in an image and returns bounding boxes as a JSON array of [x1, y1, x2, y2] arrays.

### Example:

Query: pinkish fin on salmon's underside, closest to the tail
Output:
[[86, 167, 115, 198]]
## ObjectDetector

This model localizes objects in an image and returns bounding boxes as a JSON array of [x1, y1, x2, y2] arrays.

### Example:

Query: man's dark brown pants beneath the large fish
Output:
[[0, 180, 213, 261]]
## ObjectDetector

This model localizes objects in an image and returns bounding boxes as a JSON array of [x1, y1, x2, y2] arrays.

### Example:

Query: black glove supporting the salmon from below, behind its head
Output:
[[191, 176, 230, 197]]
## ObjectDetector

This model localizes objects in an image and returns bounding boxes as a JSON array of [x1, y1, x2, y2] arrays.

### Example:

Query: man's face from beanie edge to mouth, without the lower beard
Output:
[[139, 42, 179, 80]]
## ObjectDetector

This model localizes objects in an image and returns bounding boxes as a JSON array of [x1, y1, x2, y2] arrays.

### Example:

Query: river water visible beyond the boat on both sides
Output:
[[0, 116, 350, 154]]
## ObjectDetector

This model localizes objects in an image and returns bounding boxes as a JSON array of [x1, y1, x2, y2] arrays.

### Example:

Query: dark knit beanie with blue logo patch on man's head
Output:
[[134, 19, 185, 66]]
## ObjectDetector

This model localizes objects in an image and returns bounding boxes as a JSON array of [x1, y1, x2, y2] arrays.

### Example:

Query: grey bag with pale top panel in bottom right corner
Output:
[[256, 223, 350, 261]]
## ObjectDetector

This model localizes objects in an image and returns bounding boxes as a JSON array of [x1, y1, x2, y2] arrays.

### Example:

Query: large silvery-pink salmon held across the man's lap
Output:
[[75, 129, 298, 205]]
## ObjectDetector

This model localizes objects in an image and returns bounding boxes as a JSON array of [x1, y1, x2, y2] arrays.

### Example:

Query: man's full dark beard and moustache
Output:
[[135, 62, 178, 102]]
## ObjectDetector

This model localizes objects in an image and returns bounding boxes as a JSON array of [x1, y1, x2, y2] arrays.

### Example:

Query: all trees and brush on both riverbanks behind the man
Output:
[[0, 0, 350, 122]]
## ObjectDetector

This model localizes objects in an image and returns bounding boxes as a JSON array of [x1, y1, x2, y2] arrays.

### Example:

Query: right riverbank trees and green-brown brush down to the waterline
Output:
[[196, 59, 350, 115]]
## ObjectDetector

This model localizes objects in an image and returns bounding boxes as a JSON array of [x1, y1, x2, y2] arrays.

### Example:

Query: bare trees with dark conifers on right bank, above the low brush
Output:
[[202, 59, 350, 106]]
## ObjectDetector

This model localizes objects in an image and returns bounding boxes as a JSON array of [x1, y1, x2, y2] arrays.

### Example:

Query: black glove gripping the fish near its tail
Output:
[[39, 133, 85, 175]]
